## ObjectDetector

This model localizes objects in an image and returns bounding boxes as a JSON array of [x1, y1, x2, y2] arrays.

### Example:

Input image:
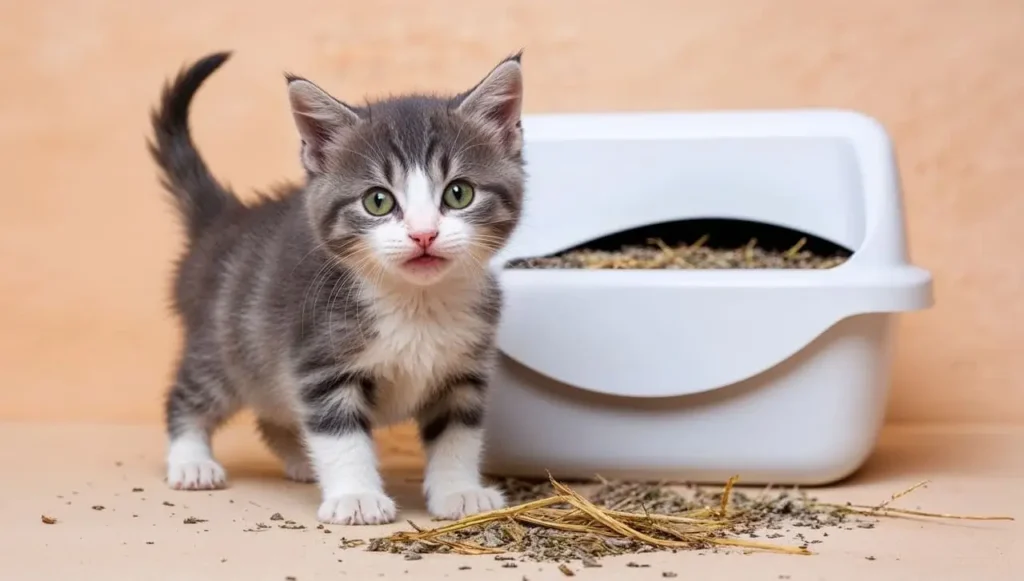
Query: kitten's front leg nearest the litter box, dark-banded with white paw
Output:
[[417, 373, 505, 521]]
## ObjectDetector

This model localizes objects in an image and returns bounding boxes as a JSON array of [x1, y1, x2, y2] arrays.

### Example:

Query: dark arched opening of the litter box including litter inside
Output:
[[505, 218, 853, 269]]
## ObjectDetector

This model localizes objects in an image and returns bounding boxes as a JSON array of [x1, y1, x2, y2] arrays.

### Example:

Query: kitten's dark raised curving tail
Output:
[[147, 52, 242, 239]]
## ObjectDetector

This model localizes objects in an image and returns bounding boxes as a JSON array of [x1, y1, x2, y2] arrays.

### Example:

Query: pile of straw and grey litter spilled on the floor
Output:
[[368, 479, 1012, 567]]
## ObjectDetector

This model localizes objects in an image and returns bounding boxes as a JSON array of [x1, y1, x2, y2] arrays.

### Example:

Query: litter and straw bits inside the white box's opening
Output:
[[505, 237, 849, 269]]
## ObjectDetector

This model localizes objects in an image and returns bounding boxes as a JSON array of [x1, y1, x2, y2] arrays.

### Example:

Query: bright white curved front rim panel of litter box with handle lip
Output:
[[497, 268, 927, 398]]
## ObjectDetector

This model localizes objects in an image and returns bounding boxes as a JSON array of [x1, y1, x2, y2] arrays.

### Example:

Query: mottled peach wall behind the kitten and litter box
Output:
[[0, 0, 1024, 421]]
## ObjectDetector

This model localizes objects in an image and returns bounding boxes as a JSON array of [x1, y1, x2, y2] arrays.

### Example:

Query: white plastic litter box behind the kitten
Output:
[[484, 110, 933, 486]]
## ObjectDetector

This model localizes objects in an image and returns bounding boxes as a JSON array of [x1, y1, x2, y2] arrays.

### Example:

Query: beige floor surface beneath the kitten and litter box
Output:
[[6, 423, 1024, 581]]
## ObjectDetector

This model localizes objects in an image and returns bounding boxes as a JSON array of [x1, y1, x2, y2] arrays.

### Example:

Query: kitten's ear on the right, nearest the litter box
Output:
[[458, 51, 522, 149]]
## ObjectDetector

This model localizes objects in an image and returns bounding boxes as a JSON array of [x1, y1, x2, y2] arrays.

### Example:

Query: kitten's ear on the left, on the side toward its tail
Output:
[[286, 75, 359, 173]]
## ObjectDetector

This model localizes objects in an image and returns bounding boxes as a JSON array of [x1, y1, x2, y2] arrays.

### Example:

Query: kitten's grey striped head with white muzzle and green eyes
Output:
[[288, 54, 524, 285]]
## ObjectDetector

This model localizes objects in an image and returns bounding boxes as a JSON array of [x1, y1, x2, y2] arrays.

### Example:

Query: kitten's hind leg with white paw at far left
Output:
[[165, 360, 238, 490]]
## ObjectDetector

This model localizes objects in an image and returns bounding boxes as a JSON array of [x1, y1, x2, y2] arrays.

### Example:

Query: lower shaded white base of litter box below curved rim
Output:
[[484, 315, 892, 486]]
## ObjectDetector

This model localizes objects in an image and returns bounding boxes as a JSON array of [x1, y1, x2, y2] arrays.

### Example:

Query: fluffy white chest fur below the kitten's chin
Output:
[[357, 278, 487, 425]]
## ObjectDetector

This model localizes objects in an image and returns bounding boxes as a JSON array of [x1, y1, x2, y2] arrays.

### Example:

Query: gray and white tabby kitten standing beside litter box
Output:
[[150, 52, 525, 524]]
